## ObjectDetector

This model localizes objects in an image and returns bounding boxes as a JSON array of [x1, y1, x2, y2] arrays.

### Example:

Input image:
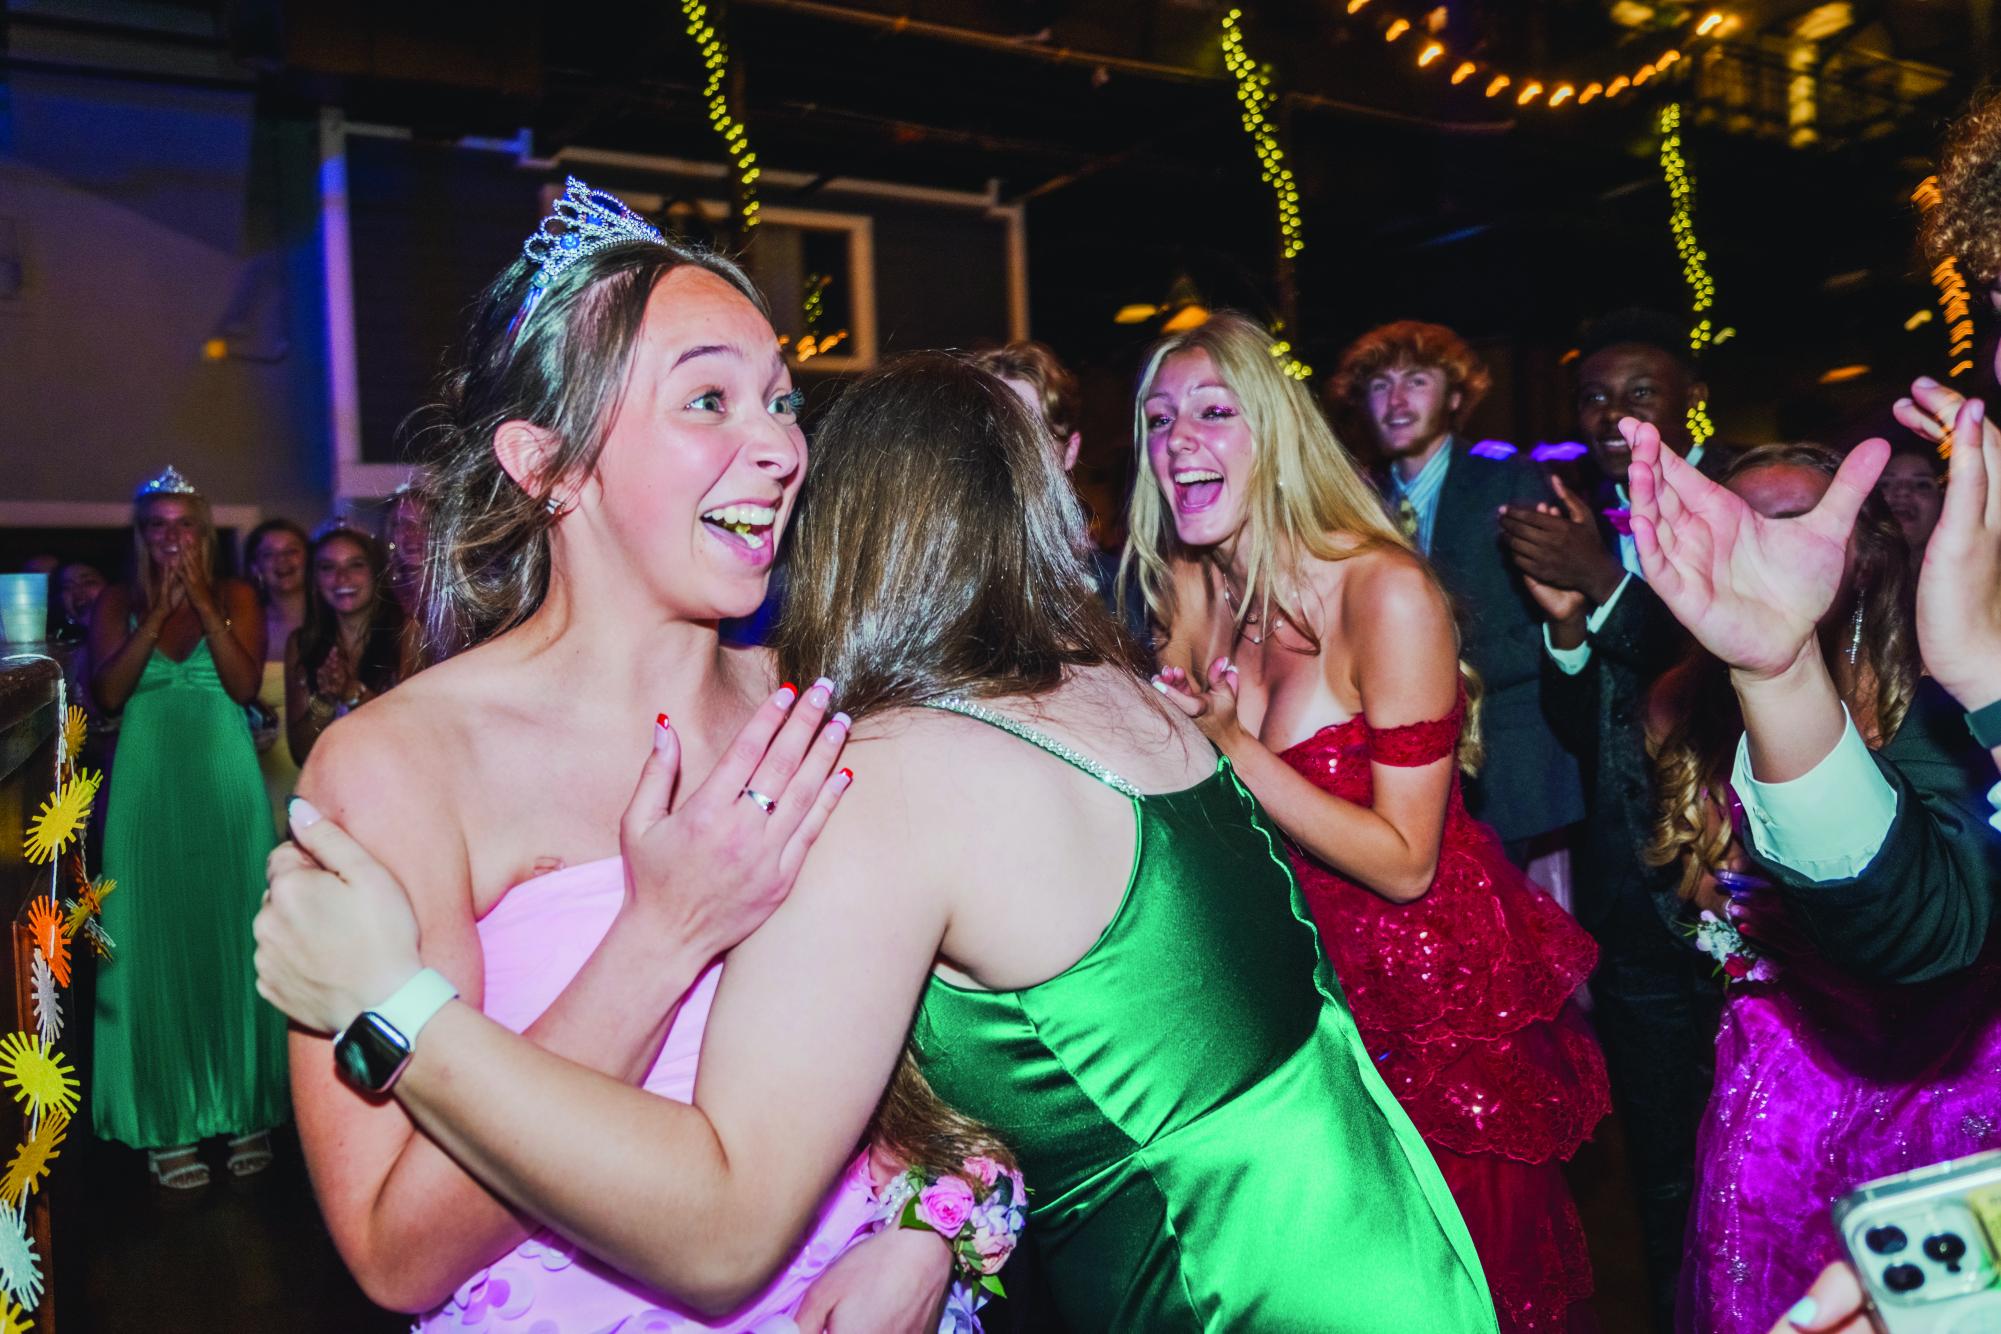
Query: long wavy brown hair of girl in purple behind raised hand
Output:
[[1643, 444, 1923, 898]]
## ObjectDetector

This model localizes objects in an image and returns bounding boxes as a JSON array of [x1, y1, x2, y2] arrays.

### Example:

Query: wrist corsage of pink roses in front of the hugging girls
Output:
[[876, 1156, 1029, 1334]]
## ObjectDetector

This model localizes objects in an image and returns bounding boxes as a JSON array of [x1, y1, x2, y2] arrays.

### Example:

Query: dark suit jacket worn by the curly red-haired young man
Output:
[[1429, 436, 1585, 840]]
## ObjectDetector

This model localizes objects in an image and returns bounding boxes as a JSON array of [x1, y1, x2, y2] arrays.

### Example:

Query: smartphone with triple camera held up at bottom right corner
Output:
[[1835, 1150, 2001, 1334]]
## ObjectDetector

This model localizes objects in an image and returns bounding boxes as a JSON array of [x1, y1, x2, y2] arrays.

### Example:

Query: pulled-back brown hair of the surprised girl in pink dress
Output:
[[412, 240, 766, 664]]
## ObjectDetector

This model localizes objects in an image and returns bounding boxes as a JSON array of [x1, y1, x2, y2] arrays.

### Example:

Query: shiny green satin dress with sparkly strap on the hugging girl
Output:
[[912, 700, 1495, 1334]]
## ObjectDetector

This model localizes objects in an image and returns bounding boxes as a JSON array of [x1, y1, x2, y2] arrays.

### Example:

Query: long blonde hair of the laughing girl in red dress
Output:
[[1119, 310, 1483, 774]]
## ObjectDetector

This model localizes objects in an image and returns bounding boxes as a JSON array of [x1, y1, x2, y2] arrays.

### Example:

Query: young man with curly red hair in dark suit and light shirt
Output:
[[1333, 320, 1583, 866]]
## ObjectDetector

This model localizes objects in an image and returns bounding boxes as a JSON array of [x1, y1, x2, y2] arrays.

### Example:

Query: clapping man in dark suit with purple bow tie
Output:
[[1501, 310, 1719, 1330]]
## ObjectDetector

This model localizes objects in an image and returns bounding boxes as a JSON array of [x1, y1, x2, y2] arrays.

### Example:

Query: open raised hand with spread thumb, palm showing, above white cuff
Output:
[[1619, 418, 1889, 680]]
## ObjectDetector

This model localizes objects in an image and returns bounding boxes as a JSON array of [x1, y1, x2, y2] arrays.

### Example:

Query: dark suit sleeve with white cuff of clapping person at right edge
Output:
[[1755, 678, 2001, 982]]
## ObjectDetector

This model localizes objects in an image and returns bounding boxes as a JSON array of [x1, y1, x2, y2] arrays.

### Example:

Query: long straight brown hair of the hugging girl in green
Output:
[[772, 352, 1151, 1170]]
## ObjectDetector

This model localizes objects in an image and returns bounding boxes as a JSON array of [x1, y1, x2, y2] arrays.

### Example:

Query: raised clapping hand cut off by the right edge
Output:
[[1895, 380, 2001, 712]]
